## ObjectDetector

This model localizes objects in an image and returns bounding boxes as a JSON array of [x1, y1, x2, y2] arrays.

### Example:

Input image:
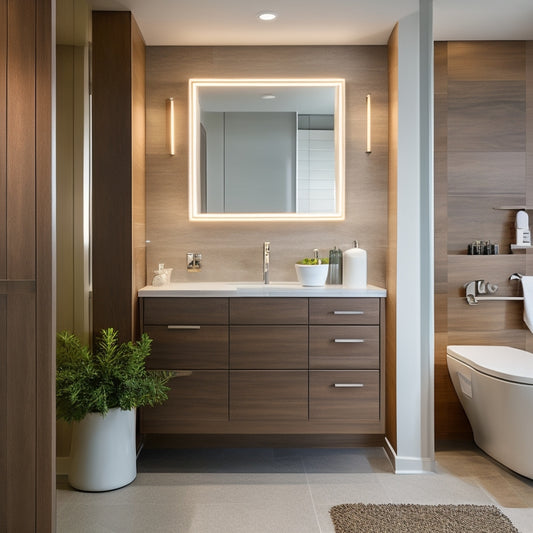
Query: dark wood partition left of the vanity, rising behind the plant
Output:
[[92, 11, 146, 341]]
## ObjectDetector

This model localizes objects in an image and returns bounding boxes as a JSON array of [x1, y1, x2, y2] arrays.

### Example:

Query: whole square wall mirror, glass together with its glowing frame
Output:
[[189, 80, 344, 220]]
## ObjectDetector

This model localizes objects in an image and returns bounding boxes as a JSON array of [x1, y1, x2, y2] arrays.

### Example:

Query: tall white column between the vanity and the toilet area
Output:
[[388, 0, 434, 473]]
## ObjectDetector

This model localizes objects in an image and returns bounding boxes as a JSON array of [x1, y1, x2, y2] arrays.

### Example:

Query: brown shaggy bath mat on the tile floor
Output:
[[330, 503, 518, 533]]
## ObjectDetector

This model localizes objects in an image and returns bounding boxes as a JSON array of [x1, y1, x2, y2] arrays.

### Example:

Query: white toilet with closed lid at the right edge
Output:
[[446, 346, 533, 479]]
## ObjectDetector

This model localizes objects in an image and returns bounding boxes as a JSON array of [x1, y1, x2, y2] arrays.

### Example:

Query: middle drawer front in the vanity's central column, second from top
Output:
[[230, 326, 308, 370]]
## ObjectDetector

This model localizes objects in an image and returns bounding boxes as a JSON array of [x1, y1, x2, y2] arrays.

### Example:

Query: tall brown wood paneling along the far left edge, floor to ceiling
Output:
[[0, 0, 55, 532]]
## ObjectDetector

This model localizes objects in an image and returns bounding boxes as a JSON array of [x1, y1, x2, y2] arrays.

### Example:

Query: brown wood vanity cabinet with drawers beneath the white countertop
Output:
[[140, 297, 384, 435]]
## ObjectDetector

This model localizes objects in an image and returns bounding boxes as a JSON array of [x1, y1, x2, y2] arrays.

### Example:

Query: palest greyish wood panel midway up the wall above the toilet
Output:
[[447, 152, 526, 197]]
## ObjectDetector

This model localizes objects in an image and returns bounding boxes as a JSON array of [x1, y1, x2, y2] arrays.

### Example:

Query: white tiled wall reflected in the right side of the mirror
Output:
[[297, 130, 335, 213]]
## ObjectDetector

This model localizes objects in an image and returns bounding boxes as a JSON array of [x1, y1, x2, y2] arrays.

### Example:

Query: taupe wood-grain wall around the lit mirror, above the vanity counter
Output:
[[146, 46, 388, 286]]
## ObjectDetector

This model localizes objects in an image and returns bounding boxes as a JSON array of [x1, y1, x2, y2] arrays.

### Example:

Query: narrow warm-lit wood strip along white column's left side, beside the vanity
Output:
[[385, 25, 398, 450]]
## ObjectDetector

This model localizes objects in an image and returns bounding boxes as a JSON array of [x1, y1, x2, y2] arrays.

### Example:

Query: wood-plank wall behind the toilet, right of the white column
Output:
[[435, 41, 533, 439]]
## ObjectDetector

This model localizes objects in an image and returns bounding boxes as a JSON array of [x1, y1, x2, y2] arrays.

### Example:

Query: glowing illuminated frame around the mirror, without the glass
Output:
[[189, 79, 345, 221]]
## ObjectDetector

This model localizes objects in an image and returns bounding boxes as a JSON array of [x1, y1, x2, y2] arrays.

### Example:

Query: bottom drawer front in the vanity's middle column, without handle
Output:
[[229, 370, 308, 420]]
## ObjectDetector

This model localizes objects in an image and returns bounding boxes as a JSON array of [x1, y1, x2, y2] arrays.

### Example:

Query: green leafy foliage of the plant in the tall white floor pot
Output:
[[56, 328, 173, 422]]
